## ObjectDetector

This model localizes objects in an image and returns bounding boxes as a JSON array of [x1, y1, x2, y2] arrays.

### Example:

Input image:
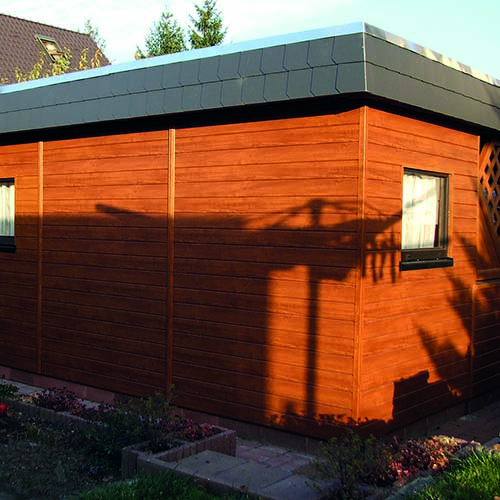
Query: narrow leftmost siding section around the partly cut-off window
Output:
[[0, 144, 39, 371]]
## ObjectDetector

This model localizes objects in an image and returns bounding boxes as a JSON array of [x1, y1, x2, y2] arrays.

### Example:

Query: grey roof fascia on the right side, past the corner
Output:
[[365, 34, 500, 130]]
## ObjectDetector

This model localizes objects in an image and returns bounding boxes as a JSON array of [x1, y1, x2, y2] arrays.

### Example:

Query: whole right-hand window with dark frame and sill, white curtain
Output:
[[400, 169, 453, 270]]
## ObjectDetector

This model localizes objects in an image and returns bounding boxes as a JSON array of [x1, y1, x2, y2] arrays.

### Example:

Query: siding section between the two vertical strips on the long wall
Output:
[[42, 132, 168, 395]]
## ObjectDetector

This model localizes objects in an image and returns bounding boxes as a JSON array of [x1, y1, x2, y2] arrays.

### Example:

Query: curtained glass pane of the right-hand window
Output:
[[402, 172, 443, 250]]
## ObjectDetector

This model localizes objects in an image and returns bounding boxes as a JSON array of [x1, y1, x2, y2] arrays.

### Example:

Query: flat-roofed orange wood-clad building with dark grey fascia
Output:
[[0, 24, 500, 437]]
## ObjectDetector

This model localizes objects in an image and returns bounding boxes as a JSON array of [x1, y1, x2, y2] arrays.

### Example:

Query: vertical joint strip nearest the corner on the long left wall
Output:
[[165, 129, 175, 394]]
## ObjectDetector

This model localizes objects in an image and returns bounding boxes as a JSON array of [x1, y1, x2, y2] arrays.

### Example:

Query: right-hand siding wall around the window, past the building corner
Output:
[[359, 109, 479, 426]]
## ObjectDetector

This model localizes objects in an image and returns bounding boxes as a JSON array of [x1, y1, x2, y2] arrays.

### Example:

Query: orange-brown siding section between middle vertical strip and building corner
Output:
[[173, 110, 360, 431]]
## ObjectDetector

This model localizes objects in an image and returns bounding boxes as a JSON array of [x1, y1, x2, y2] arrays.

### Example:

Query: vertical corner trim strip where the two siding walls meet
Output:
[[353, 107, 367, 422]]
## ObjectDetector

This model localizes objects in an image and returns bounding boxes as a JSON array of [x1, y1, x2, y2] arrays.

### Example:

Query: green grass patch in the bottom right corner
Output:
[[406, 451, 500, 500]]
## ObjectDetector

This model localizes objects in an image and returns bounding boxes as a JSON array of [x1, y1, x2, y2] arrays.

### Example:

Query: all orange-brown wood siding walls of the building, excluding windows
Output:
[[0, 108, 500, 436]]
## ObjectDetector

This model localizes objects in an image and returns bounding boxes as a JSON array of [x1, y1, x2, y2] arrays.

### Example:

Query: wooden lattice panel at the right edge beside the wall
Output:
[[479, 144, 500, 238]]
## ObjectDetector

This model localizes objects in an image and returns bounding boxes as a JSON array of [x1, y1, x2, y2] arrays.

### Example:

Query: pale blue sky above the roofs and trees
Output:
[[0, 0, 500, 79]]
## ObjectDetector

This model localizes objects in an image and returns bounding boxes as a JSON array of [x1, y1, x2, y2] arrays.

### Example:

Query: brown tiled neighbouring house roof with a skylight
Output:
[[0, 14, 110, 83]]
